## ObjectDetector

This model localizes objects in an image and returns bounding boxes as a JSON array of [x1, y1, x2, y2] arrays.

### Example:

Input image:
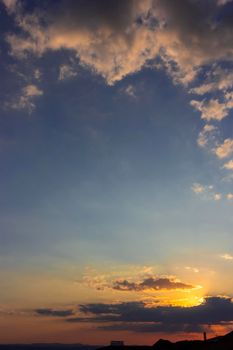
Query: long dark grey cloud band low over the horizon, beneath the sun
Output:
[[67, 296, 233, 332]]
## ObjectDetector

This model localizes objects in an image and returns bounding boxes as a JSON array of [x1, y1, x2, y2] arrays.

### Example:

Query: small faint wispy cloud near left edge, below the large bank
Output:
[[6, 84, 43, 113]]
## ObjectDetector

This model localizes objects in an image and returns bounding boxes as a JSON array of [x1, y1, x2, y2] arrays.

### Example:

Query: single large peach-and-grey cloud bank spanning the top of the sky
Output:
[[4, 0, 233, 85]]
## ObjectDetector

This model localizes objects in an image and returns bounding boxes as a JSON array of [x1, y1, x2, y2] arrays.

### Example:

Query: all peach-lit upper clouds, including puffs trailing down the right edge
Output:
[[2, 0, 233, 180]]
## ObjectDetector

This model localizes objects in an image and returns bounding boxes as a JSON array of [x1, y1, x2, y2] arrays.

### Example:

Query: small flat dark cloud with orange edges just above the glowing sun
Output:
[[112, 277, 195, 291]]
